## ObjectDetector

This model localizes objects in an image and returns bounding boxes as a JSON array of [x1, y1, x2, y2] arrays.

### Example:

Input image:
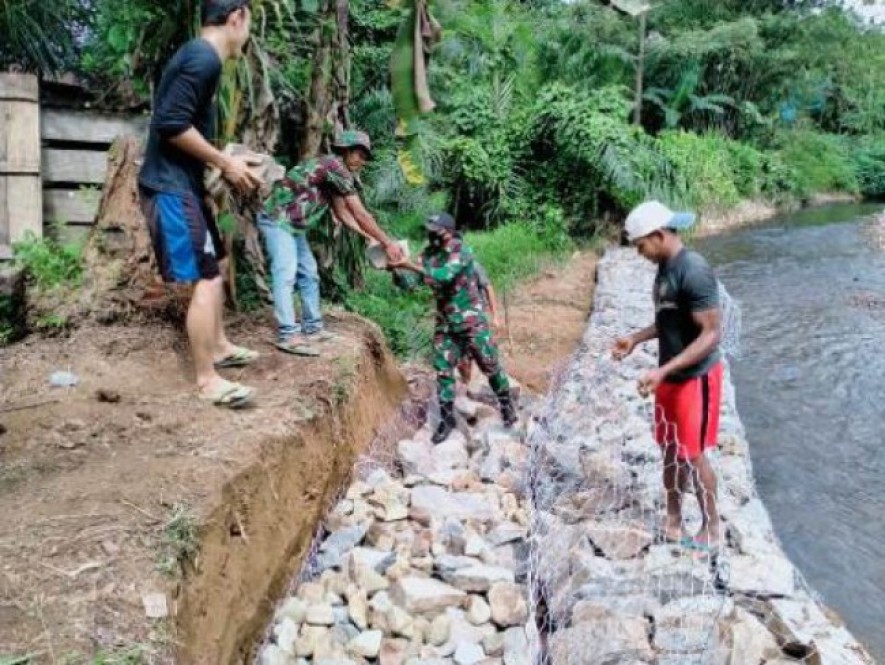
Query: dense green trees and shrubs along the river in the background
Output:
[[0, 0, 885, 353]]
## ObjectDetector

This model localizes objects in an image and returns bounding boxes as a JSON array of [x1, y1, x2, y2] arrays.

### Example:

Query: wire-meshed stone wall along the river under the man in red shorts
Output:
[[527, 249, 873, 665]]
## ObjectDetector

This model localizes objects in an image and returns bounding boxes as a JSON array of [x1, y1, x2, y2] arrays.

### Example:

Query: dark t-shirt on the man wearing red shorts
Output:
[[654, 249, 720, 383]]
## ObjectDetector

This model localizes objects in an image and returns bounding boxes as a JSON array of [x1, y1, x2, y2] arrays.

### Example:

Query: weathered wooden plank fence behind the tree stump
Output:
[[0, 74, 148, 259]]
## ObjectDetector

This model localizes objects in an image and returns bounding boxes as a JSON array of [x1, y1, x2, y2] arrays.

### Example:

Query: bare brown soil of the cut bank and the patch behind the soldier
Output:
[[0, 246, 596, 663]]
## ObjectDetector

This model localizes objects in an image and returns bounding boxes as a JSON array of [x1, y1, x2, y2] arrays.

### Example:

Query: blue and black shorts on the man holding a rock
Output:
[[140, 187, 224, 282]]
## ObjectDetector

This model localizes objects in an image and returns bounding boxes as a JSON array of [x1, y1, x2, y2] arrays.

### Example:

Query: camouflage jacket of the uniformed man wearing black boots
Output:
[[422, 237, 489, 333]]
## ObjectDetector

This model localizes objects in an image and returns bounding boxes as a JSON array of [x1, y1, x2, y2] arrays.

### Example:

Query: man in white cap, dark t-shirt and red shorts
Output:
[[613, 201, 722, 552]]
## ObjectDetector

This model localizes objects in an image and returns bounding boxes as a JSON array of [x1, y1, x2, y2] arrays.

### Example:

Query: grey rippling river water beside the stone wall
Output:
[[697, 205, 885, 663]]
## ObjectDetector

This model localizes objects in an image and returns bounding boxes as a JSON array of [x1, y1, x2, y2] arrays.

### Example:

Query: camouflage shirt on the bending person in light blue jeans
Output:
[[264, 155, 358, 232]]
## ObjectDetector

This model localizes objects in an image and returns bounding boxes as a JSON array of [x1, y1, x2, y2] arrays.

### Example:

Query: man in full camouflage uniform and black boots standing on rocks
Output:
[[400, 213, 517, 443]]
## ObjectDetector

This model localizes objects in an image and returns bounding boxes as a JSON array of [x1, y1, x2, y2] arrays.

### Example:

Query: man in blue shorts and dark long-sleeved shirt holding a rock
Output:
[[138, 0, 260, 407]]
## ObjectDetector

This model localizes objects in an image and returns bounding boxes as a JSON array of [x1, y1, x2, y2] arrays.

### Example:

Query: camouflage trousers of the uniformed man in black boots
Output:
[[433, 326, 510, 404]]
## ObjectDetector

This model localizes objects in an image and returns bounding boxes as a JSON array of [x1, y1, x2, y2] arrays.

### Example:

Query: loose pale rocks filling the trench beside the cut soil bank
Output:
[[260, 399, 532, 665]]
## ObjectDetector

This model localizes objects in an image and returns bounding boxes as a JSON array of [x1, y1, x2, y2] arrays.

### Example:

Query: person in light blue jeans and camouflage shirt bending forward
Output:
[[258, 130, 402, 356]]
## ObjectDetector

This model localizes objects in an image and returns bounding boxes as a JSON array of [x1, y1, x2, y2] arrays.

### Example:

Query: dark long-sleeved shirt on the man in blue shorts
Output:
[[138, 39, 222, 197]]
